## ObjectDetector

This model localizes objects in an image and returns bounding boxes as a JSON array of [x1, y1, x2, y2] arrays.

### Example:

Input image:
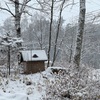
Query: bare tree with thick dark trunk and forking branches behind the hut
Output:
[[0, 0, 31, 47]]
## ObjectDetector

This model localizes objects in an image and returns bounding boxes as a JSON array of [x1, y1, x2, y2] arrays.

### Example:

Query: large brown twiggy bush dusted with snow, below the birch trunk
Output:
[[44, 66, 100, 100]]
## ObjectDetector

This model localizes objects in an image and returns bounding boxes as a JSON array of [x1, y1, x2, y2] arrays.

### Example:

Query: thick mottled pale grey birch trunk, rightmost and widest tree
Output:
[[74, 0, 86, 67]]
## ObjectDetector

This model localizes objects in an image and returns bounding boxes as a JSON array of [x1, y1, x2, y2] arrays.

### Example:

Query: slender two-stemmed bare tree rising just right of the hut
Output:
[[34, 0, 72, 67]]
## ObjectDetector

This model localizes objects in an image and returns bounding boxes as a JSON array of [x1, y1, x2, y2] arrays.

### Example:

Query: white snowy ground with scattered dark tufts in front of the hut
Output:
[[0, 66, 100, 100]]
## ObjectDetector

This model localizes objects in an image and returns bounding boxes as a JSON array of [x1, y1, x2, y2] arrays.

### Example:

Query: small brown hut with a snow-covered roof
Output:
[[18, 50, 47, 74]]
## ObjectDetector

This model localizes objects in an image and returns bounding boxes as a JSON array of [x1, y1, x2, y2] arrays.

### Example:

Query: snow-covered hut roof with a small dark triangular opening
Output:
[[20, 50, 47, 61]]
